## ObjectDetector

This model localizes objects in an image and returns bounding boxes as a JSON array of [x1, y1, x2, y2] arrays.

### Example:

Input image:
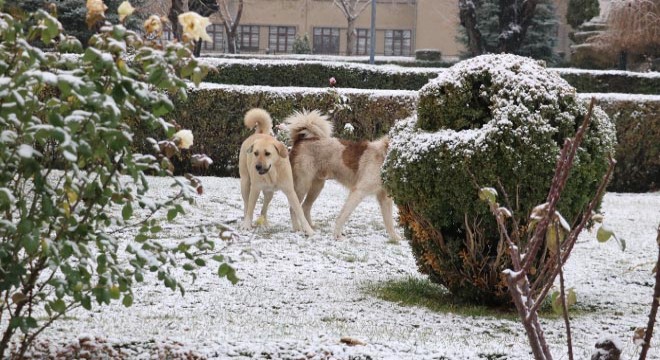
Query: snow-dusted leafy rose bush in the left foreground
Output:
[[0, 0, 237, 358]]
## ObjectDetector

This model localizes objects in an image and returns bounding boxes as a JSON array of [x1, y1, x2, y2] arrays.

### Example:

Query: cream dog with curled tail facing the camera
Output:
[[238, 109, 314, 235]]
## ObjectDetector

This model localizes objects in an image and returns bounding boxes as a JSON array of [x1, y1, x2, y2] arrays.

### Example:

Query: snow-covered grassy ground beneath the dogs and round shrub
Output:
[[32, 177, 660, 360]]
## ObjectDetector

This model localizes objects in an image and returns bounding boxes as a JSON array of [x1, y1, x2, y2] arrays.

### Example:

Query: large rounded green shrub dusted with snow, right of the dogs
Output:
[[383, 55, 616, 305]]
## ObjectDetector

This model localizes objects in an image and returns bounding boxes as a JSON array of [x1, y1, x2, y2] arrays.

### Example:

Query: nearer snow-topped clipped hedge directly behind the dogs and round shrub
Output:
[[135, 84, 660, 192]]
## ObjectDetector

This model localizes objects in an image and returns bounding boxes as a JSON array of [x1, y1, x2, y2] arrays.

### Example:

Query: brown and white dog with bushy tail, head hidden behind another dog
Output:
[[285, 110, 401, 241]]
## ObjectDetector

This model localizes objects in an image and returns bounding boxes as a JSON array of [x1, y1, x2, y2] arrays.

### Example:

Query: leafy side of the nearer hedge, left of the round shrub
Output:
[[131, 89, 414, 176]]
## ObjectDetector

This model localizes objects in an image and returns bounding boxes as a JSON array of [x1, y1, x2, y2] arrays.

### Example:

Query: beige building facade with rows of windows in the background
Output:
[[160, 0, 569, 59]]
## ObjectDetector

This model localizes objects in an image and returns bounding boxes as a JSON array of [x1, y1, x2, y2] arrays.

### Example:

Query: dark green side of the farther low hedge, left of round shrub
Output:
[[201, 61, 438, 90]]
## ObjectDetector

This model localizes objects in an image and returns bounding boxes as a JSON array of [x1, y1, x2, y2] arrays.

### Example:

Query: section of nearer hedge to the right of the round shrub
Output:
[[600, 100, 660, 192]]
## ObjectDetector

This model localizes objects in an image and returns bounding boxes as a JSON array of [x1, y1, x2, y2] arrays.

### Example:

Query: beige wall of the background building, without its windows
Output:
[[150, 0, 570, 57]]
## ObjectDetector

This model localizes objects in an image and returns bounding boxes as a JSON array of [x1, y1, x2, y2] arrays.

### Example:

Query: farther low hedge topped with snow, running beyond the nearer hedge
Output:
[[203, 58, 660, 95]]
